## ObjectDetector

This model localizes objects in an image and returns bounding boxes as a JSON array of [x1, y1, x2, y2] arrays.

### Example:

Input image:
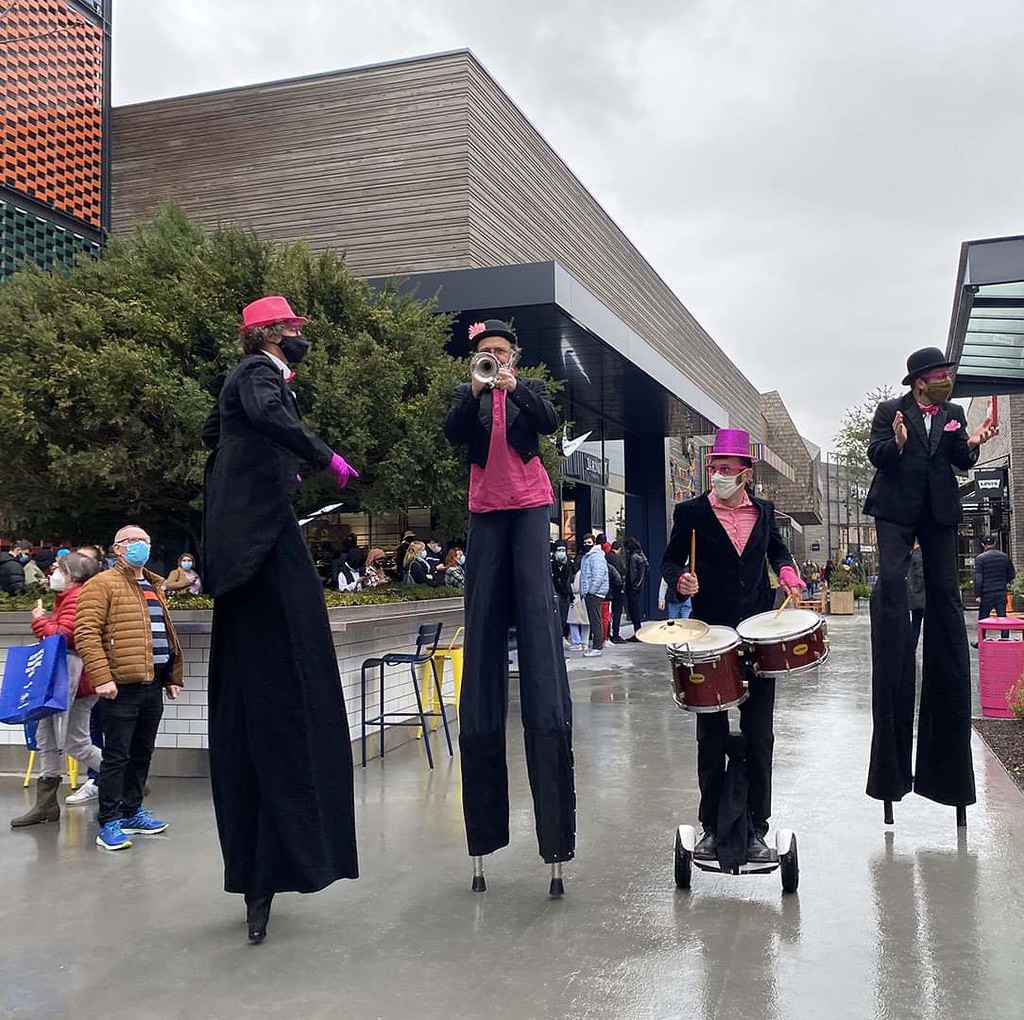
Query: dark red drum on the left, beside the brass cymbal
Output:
[[669, 627, 748, 712]]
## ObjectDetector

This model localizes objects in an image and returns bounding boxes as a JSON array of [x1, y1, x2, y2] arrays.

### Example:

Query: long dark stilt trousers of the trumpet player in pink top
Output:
[[459, 507, 575, 863]]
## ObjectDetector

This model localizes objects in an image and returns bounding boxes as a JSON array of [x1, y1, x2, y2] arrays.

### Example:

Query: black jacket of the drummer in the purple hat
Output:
[[662, 493, 796, 627]]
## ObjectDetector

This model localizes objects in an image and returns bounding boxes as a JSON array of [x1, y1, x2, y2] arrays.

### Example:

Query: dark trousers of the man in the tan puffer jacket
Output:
[[96, 680, 164, 825]]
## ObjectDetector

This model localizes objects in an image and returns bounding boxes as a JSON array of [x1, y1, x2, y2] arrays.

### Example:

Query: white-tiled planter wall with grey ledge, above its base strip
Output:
[[0, 602, 463, 748]]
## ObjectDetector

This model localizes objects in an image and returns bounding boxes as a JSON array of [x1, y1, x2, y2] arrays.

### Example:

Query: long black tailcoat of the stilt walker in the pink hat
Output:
[[203, 354, 334, 596]]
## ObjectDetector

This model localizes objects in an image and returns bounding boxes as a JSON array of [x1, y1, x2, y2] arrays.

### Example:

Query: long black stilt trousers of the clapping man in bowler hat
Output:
[[867, 515, 976, 805]]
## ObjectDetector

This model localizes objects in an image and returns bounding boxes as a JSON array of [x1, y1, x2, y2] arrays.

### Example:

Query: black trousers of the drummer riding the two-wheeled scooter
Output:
[[697, 676, 775, 836]]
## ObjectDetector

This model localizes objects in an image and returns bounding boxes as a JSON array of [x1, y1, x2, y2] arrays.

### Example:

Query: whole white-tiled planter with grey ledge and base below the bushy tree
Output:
[[0, 597, 463, 776]]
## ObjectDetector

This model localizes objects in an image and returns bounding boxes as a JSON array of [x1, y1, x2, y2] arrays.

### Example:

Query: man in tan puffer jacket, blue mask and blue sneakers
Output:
[[75, 524, 182, 850]]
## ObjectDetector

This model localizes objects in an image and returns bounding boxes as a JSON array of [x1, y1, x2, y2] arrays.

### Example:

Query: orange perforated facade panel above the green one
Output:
[[0, 0, 103, 227]]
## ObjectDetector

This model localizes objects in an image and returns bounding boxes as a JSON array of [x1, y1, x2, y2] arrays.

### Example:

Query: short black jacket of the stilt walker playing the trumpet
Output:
[[444, 379, 558, 467]]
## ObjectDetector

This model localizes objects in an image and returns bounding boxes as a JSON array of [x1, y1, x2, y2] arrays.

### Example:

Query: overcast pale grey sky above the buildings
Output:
[[113, 0, 1024, 448]]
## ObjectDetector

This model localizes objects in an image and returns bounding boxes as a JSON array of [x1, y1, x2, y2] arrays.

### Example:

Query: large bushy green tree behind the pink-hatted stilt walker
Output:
[[0, 206, 556, 542]]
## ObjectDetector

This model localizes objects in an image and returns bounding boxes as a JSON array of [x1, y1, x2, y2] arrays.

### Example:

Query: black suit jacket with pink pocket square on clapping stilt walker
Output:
[[864, 393, 978, 525]]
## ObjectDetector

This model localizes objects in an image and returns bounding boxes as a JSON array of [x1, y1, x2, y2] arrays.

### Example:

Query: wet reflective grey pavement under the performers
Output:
[[0, 613, 1024, 1020]]
